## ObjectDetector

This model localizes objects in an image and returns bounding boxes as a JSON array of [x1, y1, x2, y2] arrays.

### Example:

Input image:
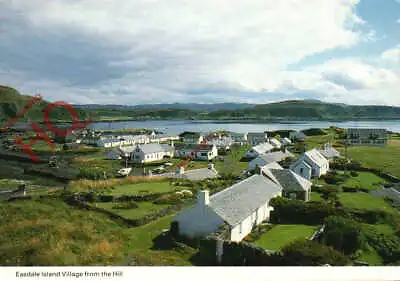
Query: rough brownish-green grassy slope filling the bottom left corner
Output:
[[0, 197, 124, 266]]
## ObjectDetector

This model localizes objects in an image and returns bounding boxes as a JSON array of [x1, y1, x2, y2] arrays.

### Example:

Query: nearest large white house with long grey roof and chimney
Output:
[[174, 174, 282, 242]]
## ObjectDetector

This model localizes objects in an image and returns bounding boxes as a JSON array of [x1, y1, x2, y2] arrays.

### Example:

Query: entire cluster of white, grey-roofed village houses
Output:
[[66, 126, 387, 244]]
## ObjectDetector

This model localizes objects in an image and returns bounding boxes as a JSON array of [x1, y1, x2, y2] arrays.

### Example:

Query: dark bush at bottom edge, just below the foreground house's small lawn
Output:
[[282, 240, 349, 266]]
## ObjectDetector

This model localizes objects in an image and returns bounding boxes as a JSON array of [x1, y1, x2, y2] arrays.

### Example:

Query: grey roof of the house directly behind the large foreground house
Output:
[[270, 169, 311, 191]]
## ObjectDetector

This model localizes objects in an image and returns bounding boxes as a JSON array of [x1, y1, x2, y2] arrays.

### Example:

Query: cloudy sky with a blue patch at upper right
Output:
[[0, 0, 400, 106]]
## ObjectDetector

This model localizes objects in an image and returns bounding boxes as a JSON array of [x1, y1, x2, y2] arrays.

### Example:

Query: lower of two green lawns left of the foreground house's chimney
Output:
[[93, 202, 168, 219]]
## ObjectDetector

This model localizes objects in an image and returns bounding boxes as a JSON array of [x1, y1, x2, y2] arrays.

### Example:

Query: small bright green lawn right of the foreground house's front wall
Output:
[[254, 224, 317, 251]]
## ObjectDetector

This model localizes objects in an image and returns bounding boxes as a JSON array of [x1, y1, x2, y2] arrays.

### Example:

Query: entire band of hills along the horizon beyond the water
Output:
[[0, 86, 400, 122]]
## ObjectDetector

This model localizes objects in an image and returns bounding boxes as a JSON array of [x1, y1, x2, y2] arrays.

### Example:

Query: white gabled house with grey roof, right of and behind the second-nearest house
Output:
[[290, 149, 329, 180]]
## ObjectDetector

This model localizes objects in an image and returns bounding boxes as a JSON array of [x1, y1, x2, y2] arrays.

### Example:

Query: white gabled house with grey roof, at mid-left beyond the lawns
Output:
[[131, 143, 174, 163]]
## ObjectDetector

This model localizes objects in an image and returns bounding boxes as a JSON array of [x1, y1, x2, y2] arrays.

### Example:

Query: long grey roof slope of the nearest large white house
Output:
[[209, 175, 282, 226]]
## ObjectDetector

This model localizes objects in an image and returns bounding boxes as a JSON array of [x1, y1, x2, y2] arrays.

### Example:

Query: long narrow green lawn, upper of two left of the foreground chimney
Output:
[[109, 181, 176, 196]]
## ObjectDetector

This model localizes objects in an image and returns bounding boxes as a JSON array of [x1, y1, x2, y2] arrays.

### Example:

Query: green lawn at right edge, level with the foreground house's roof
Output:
[[339, 192, 397, 213]]
